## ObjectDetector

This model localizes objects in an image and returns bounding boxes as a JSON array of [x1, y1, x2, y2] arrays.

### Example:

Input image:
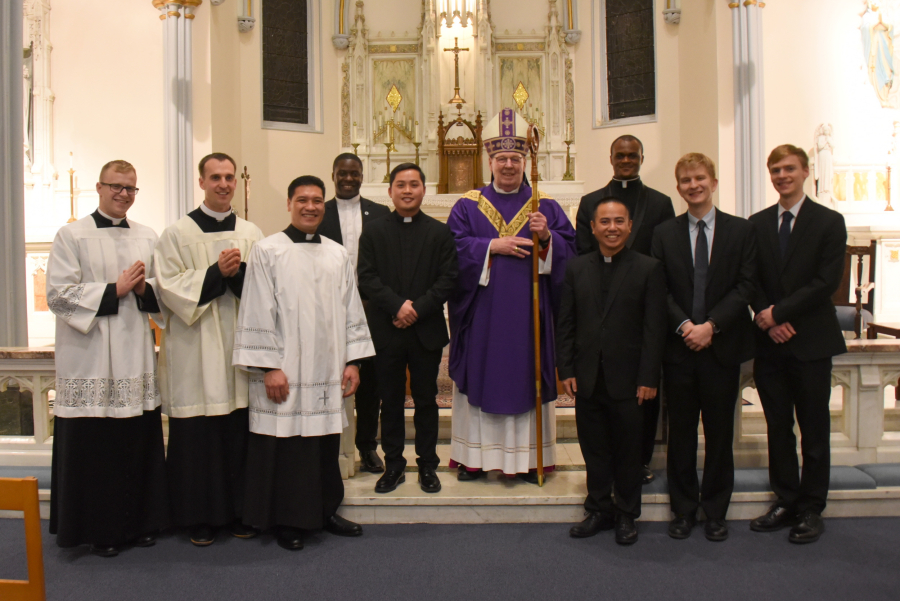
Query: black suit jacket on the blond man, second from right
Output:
[[652, 209, 756, 366]]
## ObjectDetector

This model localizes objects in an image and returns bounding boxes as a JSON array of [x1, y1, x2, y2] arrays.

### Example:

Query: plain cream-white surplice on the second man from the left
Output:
[[154, 216, 263, 418]]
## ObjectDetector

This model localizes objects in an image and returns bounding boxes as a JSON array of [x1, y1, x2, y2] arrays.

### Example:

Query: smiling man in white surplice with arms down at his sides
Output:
[[233, 175, 375, 550]]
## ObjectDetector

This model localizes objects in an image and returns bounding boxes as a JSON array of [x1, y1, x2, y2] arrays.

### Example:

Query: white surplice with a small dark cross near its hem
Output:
[[233, 232, 375, 437]]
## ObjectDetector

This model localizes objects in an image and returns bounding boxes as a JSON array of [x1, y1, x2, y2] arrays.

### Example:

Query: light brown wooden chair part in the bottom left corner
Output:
[[0, 478, 47, 601]]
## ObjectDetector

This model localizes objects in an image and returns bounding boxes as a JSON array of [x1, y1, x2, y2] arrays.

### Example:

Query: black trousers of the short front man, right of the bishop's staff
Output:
[[575, 370, 643, 518]]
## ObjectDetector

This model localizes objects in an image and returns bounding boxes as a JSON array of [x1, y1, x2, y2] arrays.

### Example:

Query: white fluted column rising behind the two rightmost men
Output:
[[728, 0, 768, 217]]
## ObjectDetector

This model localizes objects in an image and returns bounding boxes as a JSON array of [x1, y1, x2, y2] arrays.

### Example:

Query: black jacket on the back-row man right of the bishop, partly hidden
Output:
[[575, 182, 675, 257]]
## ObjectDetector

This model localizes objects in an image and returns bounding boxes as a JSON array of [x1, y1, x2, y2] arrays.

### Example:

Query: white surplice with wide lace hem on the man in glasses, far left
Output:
[[47, 216, 160, 418]]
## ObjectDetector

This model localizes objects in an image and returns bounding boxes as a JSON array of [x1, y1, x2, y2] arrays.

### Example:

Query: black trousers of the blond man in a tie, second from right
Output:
[[663, 348, 741, 520]]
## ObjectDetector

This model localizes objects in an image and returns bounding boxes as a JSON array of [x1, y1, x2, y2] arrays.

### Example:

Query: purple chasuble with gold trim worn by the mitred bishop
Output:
[[447, 184, 576, 415]]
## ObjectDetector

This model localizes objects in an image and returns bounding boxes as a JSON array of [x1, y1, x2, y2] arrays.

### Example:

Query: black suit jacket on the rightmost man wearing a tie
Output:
[[750, 196, 847, 361]]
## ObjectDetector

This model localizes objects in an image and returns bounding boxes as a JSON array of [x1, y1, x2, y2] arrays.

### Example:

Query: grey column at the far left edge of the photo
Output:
[[0, 0, 28, 346]]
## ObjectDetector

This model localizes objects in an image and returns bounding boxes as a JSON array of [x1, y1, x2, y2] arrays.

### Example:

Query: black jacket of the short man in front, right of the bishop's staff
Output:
[[556, 248, 666, 399]]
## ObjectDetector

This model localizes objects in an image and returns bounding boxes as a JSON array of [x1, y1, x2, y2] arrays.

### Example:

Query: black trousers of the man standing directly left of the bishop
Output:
[[375, 328, 441, 470]]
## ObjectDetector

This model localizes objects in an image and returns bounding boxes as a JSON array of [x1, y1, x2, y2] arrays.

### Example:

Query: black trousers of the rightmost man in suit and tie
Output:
[[753, 346, 831, 513]]
